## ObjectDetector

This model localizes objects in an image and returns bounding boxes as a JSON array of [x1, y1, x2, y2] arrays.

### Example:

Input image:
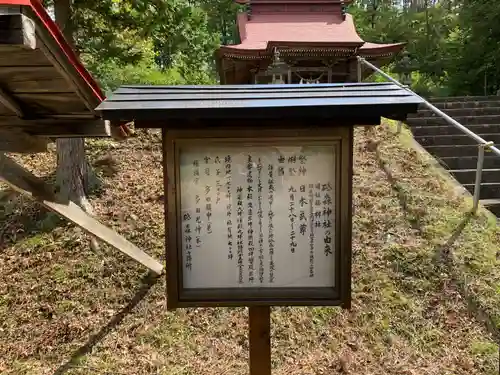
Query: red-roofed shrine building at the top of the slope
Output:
[[216, 0, 405, 84]]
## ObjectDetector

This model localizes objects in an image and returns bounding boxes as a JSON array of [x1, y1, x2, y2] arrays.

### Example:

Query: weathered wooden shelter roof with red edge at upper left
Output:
[[0, 0, 127, 152]]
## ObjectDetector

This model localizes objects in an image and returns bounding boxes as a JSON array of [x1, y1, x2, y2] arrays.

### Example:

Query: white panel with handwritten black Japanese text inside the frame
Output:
[[180, 145, 336, 288]]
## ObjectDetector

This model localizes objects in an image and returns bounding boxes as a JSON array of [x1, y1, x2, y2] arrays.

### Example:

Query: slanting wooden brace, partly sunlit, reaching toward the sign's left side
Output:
[[0, 154, 163, 275]]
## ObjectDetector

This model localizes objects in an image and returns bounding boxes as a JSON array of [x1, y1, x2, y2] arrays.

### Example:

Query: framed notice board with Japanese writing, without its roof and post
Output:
[[165, 128, 351, 308]]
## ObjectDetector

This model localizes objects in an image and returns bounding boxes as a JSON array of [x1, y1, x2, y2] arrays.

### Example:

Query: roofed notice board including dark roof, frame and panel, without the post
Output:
[[97, 83, 419, 309]]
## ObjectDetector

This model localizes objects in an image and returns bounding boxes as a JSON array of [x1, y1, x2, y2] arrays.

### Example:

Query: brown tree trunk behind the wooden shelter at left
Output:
[[54, 0, 99, 244]]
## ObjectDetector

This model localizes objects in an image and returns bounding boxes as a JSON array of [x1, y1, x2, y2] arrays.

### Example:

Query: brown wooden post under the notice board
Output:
[[248, 306, 271, 375]]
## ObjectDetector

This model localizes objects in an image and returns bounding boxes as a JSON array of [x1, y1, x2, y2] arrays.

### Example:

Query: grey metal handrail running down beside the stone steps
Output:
[[357, 56, 500, 213]]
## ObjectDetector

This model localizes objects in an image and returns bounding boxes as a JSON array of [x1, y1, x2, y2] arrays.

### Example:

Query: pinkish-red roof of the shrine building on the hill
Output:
[[220, 0, 404, 58]]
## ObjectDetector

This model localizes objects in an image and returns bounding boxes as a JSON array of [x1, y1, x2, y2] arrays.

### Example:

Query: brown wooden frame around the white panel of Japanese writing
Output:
[[162, 124, 353, 310]]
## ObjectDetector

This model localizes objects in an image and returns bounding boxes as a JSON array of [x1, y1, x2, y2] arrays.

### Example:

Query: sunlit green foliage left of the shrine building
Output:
[[45, 0, 230, 86]]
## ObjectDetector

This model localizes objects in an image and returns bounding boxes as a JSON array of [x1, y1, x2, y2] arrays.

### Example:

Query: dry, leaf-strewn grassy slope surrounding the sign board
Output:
[[0, 125, 500, 375]]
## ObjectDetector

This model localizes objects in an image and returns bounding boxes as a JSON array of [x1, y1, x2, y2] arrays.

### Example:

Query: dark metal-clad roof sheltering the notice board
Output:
[[96, 83, 422, 127]]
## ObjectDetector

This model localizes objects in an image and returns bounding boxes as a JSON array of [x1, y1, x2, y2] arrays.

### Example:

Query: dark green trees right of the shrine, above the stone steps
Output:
[[350, 0, 500, 96]]
